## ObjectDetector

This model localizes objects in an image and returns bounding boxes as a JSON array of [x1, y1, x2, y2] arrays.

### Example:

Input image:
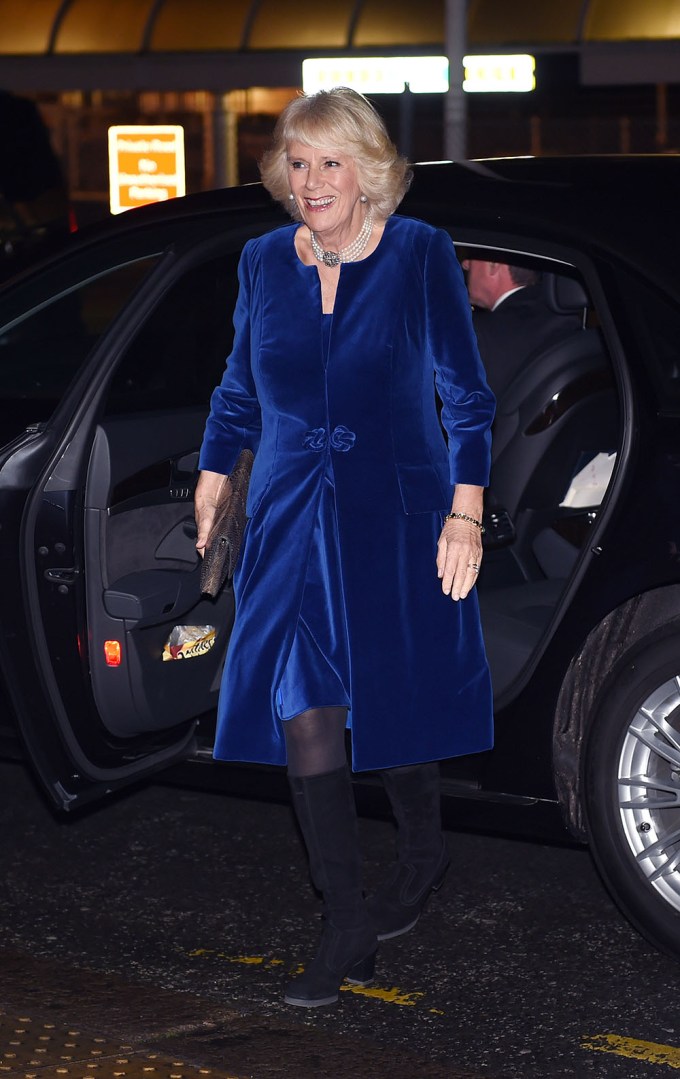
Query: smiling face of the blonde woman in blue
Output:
[[287, 142, 363, 243]]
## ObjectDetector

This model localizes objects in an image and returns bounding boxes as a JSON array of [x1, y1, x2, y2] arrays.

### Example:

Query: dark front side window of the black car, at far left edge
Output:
[[0, 256, 158, 445]]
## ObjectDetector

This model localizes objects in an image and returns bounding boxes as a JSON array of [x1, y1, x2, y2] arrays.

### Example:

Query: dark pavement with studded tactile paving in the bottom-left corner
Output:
[[0, 952, 474, 1079]]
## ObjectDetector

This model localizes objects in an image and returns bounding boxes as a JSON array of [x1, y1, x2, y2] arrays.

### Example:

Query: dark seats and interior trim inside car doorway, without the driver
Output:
[[466, 254, 618, 697]]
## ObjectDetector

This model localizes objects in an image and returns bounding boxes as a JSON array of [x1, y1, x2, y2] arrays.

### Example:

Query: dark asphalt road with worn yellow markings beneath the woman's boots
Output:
[[0, 764, 680, 1079]]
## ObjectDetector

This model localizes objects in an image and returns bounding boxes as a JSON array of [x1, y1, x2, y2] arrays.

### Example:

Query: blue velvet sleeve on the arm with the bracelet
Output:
[[424, 229, 495, 487]]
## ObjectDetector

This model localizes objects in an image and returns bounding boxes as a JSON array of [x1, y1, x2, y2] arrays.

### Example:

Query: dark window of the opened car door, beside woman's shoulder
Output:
[[106, 251, 239, 415]]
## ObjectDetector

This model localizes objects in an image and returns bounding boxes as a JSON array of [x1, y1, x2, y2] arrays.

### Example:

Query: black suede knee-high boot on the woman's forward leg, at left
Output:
[[285, 767, 378, 1008]]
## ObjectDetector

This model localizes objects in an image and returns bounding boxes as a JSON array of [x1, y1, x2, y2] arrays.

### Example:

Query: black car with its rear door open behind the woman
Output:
[[0, 156, 680, 955]]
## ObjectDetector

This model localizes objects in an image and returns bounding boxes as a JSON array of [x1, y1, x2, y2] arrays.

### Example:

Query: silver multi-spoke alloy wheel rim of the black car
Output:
[[617, 677, 680, 911]]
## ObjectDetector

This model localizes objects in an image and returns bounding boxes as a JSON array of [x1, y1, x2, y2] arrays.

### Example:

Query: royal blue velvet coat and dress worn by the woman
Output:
[[200, 216, 493, 770]]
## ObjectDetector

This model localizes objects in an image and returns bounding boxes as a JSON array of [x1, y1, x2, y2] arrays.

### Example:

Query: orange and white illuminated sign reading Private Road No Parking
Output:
[[109, 124, 186, 214]]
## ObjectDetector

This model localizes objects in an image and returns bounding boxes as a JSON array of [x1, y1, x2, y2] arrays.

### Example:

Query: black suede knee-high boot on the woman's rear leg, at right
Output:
[[366, 763, 449, 941]]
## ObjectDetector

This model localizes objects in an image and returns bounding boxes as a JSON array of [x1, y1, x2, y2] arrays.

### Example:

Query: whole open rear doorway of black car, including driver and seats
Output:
[[453, 236, 621, 699]]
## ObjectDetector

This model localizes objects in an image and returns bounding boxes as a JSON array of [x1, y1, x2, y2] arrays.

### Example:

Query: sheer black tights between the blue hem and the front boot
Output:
[[283, 708, 348, 778]]
